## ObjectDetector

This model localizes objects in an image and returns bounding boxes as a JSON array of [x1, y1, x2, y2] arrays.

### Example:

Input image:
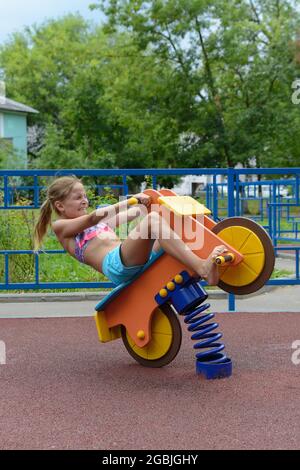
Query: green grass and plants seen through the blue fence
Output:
[[0, 199, 300, 294]]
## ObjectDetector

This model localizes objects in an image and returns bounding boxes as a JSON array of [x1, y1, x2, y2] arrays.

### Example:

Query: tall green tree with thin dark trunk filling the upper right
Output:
[[93, 0, 299, 166]]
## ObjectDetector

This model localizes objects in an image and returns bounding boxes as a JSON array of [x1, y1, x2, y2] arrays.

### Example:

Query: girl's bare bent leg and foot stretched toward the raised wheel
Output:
[[121, 212, 225, 284]]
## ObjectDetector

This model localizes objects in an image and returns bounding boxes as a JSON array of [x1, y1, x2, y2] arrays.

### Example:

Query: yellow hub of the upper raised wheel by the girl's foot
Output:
[[218, 225, 265, 286]]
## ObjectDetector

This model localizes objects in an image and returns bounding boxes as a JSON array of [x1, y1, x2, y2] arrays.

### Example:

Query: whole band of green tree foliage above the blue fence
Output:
[[0, 0, 300, 168]]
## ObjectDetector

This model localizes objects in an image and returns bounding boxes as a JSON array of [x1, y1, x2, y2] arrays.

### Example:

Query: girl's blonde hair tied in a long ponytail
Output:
[[34, 175, 81, 251]]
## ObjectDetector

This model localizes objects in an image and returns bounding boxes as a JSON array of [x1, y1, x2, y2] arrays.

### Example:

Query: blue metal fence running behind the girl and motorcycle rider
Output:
[[0, 168, 300, 310]]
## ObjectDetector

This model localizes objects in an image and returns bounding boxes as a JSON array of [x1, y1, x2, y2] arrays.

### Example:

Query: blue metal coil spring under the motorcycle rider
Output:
[[183, 304, 228, 364]]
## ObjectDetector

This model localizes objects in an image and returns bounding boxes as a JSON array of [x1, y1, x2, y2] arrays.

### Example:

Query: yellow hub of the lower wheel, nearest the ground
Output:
[[126, 308, 173, 360]]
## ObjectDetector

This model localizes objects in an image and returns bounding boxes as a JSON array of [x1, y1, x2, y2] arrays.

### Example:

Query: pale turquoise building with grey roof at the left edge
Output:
[[0, 90, 38, 168]]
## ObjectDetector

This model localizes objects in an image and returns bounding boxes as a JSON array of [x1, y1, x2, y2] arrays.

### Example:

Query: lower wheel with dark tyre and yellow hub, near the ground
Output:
[[121, 304, 182, 367]]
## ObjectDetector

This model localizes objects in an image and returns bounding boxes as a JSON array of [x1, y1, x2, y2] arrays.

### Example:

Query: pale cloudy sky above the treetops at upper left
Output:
[[0, 0, 103, 44]]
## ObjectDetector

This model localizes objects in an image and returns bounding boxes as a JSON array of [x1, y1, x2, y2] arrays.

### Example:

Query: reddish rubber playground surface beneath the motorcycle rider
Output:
[[0, 313, 300, 450]]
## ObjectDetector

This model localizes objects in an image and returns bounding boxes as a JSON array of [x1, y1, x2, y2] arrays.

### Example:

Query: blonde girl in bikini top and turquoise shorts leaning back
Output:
[[34, 176, 226, 285]]
